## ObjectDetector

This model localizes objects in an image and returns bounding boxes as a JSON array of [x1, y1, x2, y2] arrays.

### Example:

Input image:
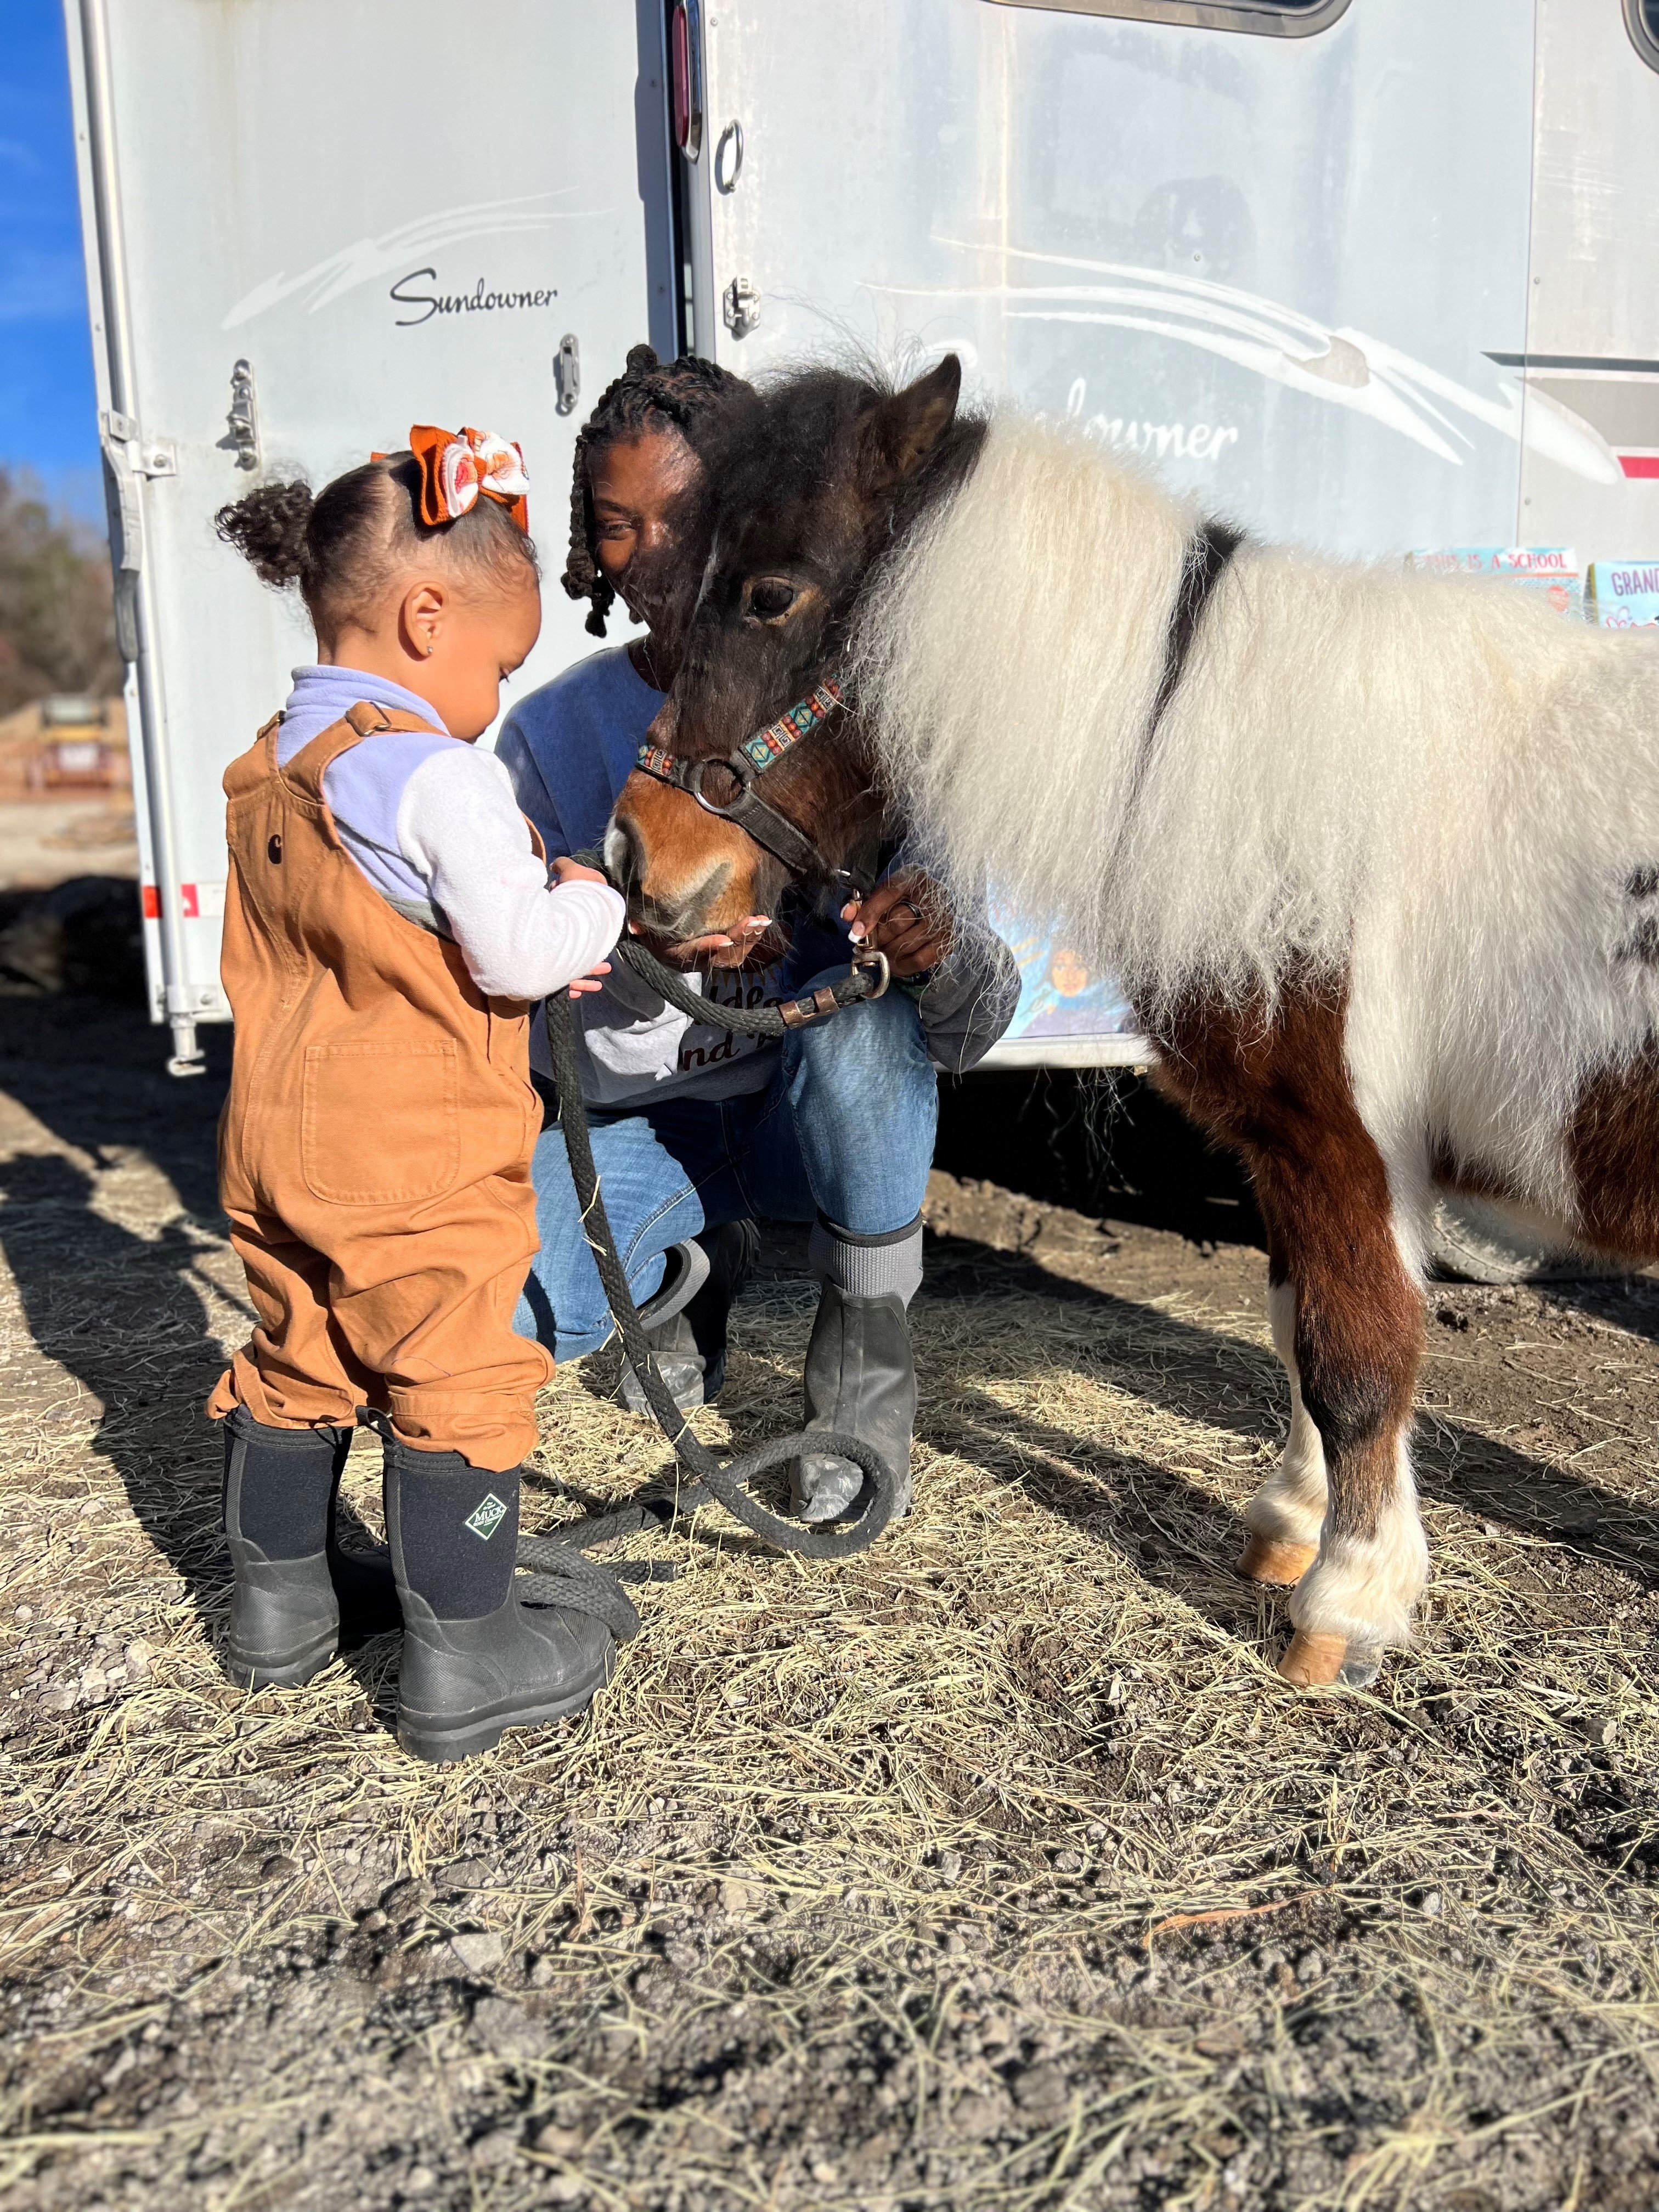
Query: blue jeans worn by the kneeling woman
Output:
[[513, 969, 938, 1361]]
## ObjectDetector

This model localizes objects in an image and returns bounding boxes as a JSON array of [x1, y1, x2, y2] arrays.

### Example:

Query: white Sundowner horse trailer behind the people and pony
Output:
[[66, 0, 1659, 1068]]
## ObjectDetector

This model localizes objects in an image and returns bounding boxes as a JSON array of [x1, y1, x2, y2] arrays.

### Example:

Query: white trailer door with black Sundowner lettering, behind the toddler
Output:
[[66, 0, 675, 1068]]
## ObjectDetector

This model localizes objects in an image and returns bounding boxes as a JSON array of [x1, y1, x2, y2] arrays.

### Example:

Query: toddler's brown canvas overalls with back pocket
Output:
[[208, 706, 553, 1471]]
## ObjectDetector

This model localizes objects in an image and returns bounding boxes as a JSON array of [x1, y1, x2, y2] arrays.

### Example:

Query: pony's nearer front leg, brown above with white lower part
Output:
[[1259, 1153, 1429, 1688]]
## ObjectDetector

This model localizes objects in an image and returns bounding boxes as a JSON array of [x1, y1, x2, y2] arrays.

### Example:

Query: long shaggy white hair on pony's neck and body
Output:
[[854, 414, 1659, 1221]]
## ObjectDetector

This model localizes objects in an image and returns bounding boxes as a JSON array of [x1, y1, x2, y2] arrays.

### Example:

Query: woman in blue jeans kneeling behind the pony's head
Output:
[[498, 345, 1020, 1522]]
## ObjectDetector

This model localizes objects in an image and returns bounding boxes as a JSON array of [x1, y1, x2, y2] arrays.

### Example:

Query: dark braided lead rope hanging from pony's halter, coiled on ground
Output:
[[517, 938, 898, 1639]]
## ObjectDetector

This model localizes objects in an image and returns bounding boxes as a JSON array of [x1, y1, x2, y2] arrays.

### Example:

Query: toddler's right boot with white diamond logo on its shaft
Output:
[[385, 1438, 615, 1763]]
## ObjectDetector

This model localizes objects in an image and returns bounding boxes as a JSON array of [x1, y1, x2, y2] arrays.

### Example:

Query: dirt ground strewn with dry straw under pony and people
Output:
[[0, 995, 1659, 2212]]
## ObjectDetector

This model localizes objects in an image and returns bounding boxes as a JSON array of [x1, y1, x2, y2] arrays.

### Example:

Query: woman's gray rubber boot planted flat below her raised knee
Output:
[[789, 1215, 922, 1522]]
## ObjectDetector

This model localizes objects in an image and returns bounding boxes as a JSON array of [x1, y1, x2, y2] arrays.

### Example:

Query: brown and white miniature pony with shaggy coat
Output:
[[617, 358, 1659, 1681]]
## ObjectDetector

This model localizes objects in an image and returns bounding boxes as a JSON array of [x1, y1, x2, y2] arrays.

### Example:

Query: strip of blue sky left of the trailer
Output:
[[0, 0, 104, 517]]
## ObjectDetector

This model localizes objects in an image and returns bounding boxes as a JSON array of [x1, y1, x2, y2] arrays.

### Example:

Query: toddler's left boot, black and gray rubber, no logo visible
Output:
[[223, 1404, 400, 1690]]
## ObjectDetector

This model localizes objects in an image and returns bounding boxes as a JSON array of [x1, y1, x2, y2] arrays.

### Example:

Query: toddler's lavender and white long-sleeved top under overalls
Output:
[[276, 668, 624, 1000]]
